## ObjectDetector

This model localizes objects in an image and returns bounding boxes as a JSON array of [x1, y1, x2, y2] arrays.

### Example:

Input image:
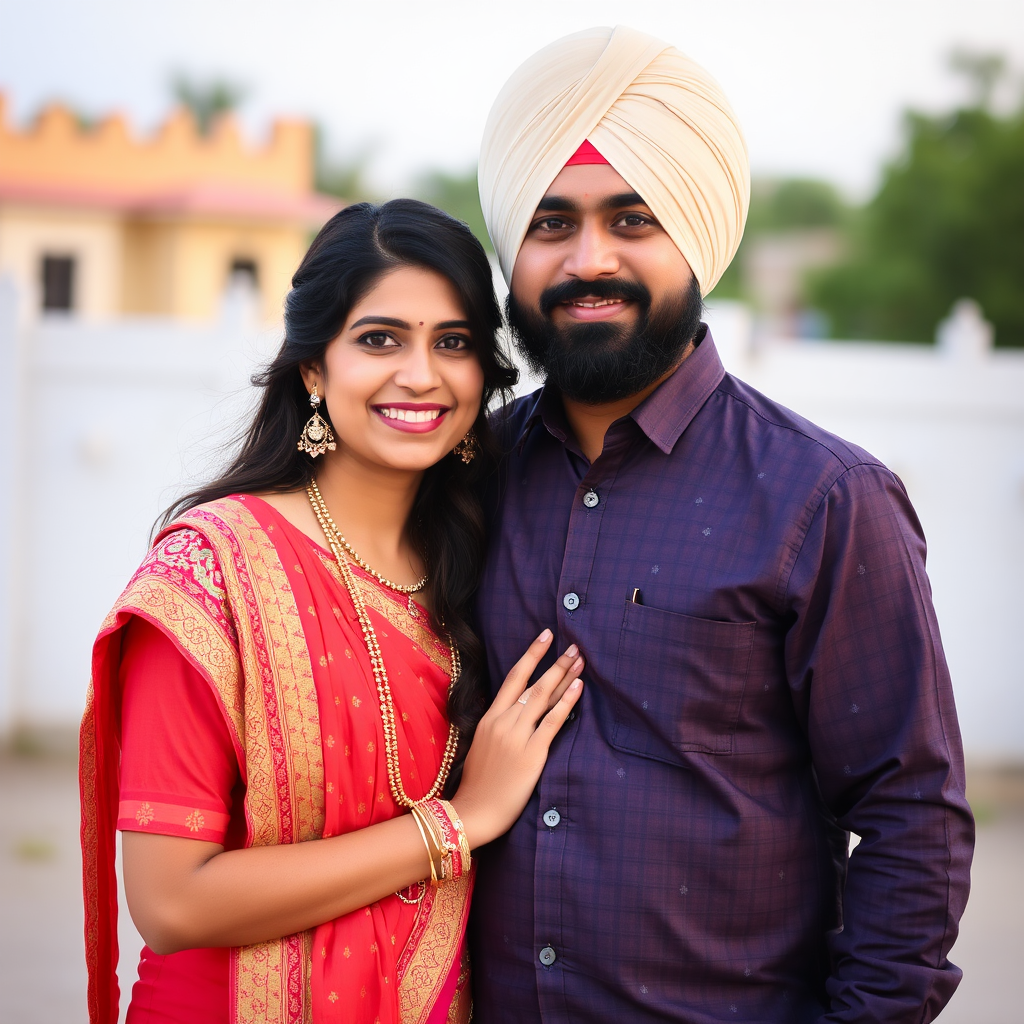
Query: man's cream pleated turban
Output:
[[479, 26, 751, 295]]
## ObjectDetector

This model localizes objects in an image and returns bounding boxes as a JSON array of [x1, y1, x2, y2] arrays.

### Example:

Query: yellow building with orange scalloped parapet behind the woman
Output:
[[0, 94, 342, 322]]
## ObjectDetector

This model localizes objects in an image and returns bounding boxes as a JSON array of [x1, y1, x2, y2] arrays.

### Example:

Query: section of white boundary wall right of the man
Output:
[[708, 303, 1024, 763]]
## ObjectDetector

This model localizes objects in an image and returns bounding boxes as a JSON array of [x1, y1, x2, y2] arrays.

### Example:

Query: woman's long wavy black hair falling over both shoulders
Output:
[[161, 199, 517, 792]]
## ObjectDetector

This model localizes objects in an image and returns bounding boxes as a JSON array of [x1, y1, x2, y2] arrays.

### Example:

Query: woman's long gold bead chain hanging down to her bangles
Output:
[[306, 483, 462, 807]]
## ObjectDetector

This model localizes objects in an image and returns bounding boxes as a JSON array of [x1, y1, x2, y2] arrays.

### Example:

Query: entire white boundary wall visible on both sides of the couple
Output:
[[0, 279, 1024, 761]]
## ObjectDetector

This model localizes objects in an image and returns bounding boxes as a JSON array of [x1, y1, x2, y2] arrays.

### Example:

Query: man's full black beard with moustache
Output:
[[505, 279, 703, 406]]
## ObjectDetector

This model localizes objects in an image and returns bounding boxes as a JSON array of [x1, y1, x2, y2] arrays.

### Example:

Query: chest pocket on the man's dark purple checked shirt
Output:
[[611, 602, 756, 764]]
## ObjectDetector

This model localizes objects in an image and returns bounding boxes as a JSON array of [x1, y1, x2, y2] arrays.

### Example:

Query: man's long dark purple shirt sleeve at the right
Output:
[[786, 465, 974, 1024]]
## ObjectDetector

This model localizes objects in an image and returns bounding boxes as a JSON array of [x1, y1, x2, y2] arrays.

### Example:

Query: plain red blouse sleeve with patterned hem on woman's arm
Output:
[[118, 617, 240, 844]]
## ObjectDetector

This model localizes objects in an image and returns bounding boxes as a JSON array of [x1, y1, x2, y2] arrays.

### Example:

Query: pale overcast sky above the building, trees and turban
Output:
[[0, 0, 1024, 196]]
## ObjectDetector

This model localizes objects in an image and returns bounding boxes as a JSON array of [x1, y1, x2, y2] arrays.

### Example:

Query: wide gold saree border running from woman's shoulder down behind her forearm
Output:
[[171, 499, 324, 1024]]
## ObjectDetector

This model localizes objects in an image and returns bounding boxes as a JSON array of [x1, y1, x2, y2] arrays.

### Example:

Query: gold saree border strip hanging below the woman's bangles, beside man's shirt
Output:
[[398, 865, 476, 1024]]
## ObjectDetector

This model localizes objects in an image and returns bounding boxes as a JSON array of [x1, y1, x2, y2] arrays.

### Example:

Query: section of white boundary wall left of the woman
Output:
[[0, 278, 280, 732]]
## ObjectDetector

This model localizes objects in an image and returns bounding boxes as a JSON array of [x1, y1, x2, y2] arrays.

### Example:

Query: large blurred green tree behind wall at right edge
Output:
[[808, 55, 1024, 346]]
